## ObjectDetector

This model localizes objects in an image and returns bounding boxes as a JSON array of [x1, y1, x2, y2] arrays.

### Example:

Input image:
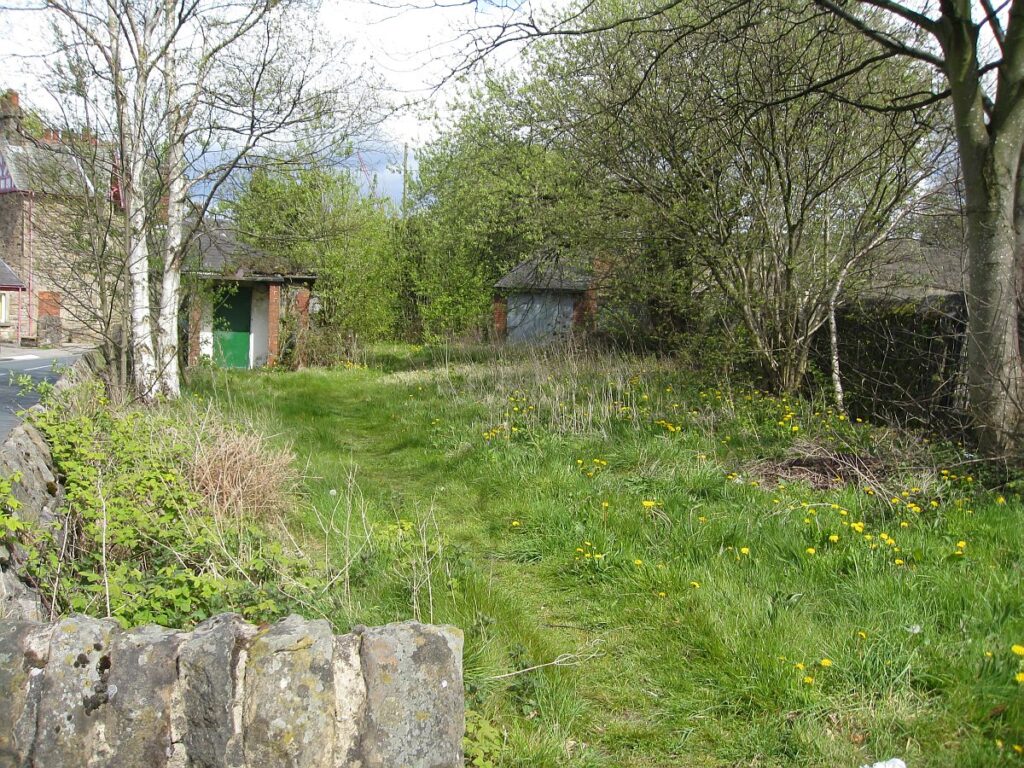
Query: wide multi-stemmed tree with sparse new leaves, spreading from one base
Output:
[[436, 2, 942, 397]]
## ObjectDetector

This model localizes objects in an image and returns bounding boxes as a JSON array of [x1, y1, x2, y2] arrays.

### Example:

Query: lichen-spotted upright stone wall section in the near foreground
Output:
[[0, 614, 464, 768]]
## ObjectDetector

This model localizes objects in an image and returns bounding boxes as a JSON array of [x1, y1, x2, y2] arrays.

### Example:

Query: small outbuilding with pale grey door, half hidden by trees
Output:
[[494, 251, 597, 343]]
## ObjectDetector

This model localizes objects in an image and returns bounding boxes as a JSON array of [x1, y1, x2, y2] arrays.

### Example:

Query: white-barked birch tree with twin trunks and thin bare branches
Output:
[[17, 0, 377, 400]]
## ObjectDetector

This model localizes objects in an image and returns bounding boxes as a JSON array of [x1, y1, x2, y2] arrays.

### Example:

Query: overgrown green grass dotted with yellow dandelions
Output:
[[193, 347, 1024, 768]]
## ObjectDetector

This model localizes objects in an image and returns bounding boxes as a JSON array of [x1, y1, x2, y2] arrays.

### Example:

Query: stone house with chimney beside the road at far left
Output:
[[0, 91, 103, 345]]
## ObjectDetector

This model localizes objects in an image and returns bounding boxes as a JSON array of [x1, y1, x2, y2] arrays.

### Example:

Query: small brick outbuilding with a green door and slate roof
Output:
[[185, 221, 316, 368]]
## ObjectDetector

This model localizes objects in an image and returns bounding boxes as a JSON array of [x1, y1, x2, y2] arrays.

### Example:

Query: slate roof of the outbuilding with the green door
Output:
[[187, 220, 316, 283]]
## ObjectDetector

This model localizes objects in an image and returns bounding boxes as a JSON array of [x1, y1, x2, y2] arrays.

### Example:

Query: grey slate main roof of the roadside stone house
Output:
[[0, 141, 94, 196]]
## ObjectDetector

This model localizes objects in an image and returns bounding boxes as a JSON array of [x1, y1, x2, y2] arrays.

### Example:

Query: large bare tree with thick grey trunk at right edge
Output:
[[459, 0, 1024, 456]]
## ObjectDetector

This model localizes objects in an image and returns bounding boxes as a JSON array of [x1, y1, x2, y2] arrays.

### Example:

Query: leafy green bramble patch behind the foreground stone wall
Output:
[[27, 381, 318, 627]]
